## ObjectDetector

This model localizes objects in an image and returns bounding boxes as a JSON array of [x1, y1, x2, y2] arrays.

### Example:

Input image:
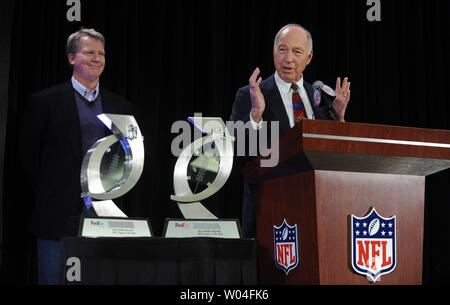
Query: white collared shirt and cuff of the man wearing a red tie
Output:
[[250, 72, 315, 130]]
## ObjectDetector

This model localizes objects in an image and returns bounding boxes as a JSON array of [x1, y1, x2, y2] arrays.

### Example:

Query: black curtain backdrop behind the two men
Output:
[[2, 0, 450, 284]]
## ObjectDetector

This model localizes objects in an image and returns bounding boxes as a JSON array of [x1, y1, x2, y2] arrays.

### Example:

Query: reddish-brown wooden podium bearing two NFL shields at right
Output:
[[243, 120, 450, 285]]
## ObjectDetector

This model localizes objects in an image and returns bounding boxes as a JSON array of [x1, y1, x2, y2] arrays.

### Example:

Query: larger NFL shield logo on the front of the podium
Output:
[[351, 208, 397, 282]]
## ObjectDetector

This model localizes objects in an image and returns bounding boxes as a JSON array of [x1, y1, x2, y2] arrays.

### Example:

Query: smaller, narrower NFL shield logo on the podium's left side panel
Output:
[[273, 219, 298, 275]]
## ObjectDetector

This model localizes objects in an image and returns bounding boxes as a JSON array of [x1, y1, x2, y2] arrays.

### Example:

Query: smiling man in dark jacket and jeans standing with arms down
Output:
[[21, 29, 132, 284]]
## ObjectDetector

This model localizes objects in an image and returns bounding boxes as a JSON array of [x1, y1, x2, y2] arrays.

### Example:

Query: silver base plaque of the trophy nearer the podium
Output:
[[163, 219, 242, 239]]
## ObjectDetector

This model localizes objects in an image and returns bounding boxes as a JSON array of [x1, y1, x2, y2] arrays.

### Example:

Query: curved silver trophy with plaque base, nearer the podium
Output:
[[163, 117, 241, 238]]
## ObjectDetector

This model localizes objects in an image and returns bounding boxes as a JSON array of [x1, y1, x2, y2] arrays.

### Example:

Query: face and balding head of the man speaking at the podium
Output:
[[273, 27, 313, 83]]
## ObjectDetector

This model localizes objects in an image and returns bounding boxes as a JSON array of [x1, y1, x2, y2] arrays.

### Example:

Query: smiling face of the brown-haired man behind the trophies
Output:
[[68, 36, 105, 82]]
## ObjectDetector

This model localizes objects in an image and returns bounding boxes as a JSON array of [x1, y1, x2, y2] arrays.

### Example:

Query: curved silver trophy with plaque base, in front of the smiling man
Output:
[[79, 114, 152, 238]]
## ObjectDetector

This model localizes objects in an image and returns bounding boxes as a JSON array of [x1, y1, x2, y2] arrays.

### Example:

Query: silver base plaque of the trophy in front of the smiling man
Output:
[[78, 217, 153, 238]]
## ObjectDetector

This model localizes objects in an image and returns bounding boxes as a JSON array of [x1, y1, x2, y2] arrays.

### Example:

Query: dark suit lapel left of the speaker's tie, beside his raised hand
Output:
[[261, 74, 291, 134]]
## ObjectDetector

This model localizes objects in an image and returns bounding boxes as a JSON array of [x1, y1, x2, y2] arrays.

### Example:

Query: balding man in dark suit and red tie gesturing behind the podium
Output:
[[230, 24, 350, 237]]
